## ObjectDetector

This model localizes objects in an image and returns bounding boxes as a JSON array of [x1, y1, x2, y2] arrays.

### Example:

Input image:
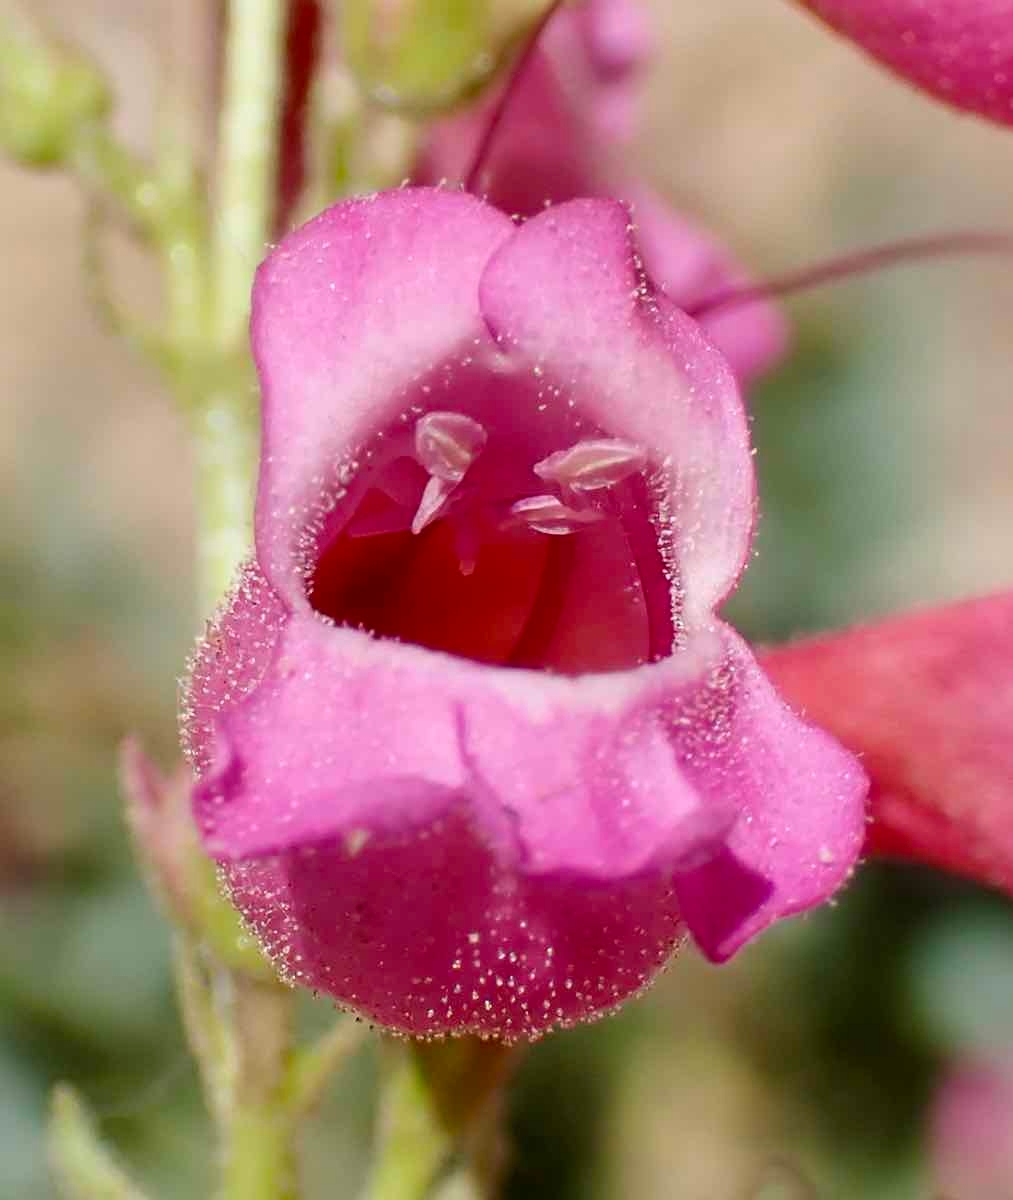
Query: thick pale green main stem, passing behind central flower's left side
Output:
[[189, 9, 299, 1200]]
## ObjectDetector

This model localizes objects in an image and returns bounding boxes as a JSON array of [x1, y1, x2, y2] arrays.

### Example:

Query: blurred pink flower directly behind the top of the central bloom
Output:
[[414, 0, 787, 382]]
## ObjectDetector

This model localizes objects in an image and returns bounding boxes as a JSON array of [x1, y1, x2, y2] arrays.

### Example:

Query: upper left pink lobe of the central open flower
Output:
[[246, 188, 514, 596]]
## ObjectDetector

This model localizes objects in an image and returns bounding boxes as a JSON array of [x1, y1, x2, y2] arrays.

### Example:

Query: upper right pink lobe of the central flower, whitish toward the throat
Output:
[[479, 200, 755, 625]]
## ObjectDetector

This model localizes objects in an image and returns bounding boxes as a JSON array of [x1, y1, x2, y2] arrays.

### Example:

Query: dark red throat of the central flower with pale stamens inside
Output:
[[310, 371, 675, 674]]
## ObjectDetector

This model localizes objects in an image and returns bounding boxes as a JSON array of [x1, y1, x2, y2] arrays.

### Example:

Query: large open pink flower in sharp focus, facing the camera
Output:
[[180, 188, 865, 1039]]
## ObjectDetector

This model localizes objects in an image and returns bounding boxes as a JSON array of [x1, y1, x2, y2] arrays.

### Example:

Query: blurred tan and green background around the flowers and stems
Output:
[[0, 0, 1013, 1200]]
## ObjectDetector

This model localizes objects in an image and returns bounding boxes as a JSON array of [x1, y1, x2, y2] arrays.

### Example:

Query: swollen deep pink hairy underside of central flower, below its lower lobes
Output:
[[217, 825, 682, 1042]]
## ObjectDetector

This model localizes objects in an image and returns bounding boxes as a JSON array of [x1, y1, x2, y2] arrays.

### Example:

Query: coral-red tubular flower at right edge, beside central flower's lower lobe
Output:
[[763, 592, 1013, 892]]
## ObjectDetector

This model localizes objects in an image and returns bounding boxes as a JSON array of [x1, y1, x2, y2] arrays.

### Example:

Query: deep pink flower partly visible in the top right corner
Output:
[[802, 0, 1013, 125]]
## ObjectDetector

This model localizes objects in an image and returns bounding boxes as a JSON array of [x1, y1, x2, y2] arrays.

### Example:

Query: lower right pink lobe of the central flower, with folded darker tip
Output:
[[676, 630, 868, 961]]
